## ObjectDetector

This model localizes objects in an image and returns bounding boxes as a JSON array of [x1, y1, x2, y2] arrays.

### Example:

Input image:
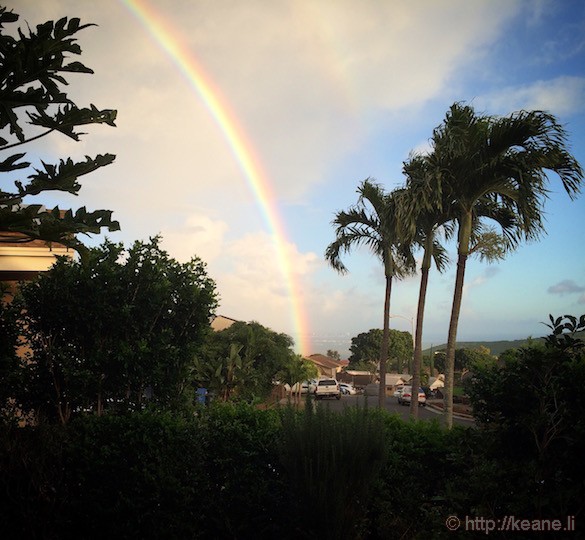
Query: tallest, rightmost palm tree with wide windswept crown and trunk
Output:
[[428, 103, 583, 427]]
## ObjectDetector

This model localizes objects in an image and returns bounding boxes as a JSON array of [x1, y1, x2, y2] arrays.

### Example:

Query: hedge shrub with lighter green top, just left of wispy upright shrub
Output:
[[194, 403, 287, 538]]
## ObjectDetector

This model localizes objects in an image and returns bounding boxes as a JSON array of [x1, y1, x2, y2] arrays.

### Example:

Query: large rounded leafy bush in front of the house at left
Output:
[[4, 238, 216, 423]]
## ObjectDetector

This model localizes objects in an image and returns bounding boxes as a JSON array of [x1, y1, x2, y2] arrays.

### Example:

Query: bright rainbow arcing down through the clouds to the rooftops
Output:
[[121, 0, 310, 354]]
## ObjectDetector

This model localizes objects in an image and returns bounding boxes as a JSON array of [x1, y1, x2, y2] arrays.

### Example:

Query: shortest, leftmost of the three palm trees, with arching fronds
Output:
[[325, 178, 415, 407]]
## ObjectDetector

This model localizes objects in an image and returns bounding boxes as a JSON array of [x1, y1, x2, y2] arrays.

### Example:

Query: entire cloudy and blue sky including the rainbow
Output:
[[4, 0, 585, 356]]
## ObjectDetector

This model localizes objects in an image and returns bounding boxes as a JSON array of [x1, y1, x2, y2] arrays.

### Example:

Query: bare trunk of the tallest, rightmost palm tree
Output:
[[444, 212, 472, 429]]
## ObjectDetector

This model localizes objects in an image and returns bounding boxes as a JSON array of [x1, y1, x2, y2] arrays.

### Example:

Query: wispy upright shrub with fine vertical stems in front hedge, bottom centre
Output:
[[280, 407, 385, 538]]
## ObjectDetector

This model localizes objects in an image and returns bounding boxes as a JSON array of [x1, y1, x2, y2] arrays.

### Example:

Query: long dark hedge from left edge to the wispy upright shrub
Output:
[[0, 405, 283, 539]]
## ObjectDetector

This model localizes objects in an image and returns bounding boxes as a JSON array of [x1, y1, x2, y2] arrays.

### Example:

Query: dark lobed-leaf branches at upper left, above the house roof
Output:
[[0, 7, 119, 251]]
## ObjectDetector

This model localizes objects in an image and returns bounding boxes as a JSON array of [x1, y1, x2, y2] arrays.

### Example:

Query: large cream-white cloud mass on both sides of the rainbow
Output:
[[8, 0, 585, 350]]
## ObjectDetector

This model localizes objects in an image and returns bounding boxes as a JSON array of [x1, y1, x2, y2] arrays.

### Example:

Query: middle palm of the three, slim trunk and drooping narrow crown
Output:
[[398, 155, 453, 418]]
